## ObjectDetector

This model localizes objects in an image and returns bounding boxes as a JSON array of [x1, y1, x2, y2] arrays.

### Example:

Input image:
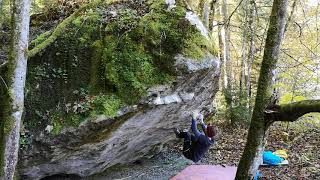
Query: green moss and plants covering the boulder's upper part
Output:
[[27, 1, 215, 132]]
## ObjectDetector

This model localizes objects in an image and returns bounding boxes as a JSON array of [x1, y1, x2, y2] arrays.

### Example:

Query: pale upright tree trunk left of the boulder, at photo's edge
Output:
[[0, 0, 31, 180]]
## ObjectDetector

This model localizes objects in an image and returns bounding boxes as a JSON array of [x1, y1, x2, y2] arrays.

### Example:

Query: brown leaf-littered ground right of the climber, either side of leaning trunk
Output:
[[208, 121, 320, 180]]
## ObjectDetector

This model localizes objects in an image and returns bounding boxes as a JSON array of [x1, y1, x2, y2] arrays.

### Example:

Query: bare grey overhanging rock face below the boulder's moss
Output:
[[20, 56, 220, 180]]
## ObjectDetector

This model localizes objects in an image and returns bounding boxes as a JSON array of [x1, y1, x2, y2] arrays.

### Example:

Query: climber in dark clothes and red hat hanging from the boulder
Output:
[[174, 110, 216, 162]]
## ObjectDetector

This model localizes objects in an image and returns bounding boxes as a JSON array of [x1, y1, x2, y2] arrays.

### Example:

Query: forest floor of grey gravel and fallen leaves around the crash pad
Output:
[[86, 120, 320, 180]]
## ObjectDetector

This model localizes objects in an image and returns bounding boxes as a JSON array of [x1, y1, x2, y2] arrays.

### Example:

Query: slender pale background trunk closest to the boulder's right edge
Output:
[[222, 0, 233, 116]]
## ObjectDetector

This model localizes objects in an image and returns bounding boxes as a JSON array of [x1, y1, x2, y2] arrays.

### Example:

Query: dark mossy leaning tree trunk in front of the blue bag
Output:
[[236, 0, 287, 180]]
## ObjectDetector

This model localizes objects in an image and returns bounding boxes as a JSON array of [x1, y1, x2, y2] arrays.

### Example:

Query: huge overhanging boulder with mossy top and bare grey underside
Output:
[[19, 0, 220, 180]]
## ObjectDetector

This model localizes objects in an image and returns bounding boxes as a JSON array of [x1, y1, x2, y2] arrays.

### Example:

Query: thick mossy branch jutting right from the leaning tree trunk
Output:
[[265, 99, 320, 122]]
